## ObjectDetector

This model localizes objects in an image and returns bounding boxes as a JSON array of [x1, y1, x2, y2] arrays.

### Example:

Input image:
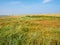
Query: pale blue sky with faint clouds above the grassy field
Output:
[[0, 0, 60, 15]]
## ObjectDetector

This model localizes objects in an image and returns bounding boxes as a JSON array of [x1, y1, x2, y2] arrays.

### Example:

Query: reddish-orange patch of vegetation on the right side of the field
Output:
[[29, 20, 60, 27]]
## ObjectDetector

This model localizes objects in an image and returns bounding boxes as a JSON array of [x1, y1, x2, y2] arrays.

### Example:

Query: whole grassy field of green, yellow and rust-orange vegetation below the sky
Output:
[[0, 15, 60, 45]]
